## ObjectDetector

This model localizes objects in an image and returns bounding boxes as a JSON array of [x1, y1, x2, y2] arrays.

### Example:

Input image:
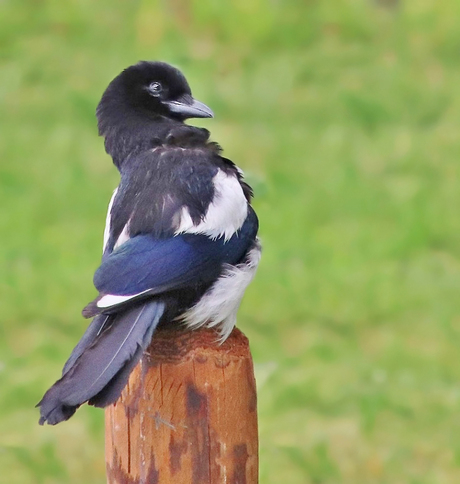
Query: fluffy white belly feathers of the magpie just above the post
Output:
[[178, 242, 261, 342]]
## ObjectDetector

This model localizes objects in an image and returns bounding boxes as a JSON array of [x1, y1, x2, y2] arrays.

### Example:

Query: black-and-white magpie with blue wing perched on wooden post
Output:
[[37, 61, 261, 425]]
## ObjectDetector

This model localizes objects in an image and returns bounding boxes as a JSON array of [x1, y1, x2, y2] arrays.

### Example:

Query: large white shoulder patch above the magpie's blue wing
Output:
[[175, 170, 248, 240]]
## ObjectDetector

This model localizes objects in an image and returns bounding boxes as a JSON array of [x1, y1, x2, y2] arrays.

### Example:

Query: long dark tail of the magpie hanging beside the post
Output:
[[37, 301, 164, 425]]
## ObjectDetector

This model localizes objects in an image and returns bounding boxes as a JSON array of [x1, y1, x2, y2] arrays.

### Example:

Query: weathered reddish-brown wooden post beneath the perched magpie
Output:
[[105, 329, 258, 484]]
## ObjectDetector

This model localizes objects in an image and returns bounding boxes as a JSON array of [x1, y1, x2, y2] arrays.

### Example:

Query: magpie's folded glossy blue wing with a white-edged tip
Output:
[[84, 208, 258, 316]]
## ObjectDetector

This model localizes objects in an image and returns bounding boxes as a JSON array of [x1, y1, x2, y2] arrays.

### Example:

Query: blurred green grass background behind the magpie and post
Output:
[[0, 0, 460, 484]]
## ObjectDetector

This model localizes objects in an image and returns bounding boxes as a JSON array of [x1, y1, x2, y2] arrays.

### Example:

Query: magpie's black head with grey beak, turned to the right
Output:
[[96, 61, 213, 166]]
